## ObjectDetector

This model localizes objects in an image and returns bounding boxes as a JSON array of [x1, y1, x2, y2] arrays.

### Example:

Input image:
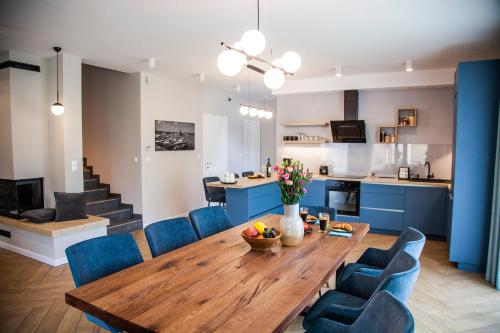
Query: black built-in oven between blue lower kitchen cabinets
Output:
[[325, 180, 361, 216]]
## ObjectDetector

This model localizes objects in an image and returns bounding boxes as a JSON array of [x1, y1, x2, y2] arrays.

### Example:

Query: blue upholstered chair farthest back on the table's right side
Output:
[[337, 227, 425, 285]]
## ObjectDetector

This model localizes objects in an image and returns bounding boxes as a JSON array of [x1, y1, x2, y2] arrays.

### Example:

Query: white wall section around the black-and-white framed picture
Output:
[[140, 73, 204, 225]]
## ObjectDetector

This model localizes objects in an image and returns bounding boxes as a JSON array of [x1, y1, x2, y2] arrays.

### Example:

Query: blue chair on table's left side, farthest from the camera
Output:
[[189, 207, 233, 239]]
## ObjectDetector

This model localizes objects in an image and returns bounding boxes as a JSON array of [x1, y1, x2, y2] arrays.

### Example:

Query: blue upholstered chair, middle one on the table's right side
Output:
[[302, 251, 420, 330]]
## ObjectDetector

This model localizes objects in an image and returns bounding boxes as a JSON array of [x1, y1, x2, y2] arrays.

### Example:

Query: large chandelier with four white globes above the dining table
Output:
[[217, 0, 302, 89]]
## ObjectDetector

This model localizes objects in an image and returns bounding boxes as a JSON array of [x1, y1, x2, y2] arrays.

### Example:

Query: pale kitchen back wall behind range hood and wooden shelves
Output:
[[276, 87, 453, 175]]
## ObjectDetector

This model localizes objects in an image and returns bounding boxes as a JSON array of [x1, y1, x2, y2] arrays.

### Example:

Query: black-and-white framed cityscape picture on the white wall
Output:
[[155, 120, 195, 151]]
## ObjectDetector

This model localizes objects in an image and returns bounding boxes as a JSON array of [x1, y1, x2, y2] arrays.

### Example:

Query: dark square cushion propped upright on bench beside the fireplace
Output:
[[54, 192, 87, 221]]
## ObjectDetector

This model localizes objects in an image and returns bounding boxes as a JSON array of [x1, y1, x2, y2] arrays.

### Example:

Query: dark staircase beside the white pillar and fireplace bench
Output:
[[83, 157, 142, 235]]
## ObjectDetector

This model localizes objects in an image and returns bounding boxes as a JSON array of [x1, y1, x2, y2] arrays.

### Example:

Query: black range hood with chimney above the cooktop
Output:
[[330, 90, 366, 143]]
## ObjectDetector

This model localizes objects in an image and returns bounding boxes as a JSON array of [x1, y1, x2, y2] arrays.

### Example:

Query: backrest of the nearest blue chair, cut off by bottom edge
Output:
[[349, 291, 415, 333]]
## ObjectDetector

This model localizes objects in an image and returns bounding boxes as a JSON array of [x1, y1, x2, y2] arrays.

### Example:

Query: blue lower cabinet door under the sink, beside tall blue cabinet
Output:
[[404, 186, 448, 236]]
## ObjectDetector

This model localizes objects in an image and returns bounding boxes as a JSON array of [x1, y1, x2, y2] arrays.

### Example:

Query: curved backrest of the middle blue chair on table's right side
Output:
[[372, 251, 420, 303]]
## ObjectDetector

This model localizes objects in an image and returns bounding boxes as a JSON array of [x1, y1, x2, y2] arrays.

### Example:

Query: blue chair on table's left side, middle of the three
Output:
[[144, 217, 198, 258]]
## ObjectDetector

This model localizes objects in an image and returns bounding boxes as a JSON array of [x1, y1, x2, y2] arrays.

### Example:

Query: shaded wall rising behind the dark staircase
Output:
[[82, 65, 142, 213]]
